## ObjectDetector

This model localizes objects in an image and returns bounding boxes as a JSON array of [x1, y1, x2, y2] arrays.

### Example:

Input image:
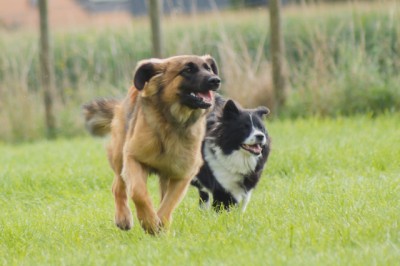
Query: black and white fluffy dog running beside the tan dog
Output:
[[191, 96, 270, 211]]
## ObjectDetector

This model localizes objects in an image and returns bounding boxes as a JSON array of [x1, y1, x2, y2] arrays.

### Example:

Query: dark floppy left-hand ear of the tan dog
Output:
[[133, 59, 161, 91]]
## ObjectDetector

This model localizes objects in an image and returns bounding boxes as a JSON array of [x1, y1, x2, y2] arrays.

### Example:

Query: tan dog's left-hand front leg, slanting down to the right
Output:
[[122, 155, 161, 234]]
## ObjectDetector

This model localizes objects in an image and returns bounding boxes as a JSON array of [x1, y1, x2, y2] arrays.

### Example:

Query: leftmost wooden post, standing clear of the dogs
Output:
[[38, 0, 56, 138]]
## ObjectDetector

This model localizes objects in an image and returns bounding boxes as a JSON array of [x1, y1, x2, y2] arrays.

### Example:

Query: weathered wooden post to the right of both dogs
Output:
[[269, 0, 287, 111]]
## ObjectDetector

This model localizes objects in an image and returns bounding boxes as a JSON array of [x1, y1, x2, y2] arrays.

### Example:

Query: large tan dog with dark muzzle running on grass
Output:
[[83, 55, 220, 233]]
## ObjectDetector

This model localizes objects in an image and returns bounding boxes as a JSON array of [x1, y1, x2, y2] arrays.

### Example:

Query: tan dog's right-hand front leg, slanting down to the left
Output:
[[157, 178, 191, 226]]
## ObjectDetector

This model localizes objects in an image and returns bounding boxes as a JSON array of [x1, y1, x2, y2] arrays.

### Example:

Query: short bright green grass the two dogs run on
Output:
[[0, 114, 400, 265]]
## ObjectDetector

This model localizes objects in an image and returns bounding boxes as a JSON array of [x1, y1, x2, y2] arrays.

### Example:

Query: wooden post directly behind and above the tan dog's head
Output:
[[149, 0, 164, 58]]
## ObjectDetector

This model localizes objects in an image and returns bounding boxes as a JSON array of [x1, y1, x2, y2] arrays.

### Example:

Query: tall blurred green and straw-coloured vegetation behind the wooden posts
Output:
[[0, 2, 400, 141]]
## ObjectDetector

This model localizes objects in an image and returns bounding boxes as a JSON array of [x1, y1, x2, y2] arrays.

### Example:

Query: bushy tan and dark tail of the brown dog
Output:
[[82, 99, 119, 136]]
